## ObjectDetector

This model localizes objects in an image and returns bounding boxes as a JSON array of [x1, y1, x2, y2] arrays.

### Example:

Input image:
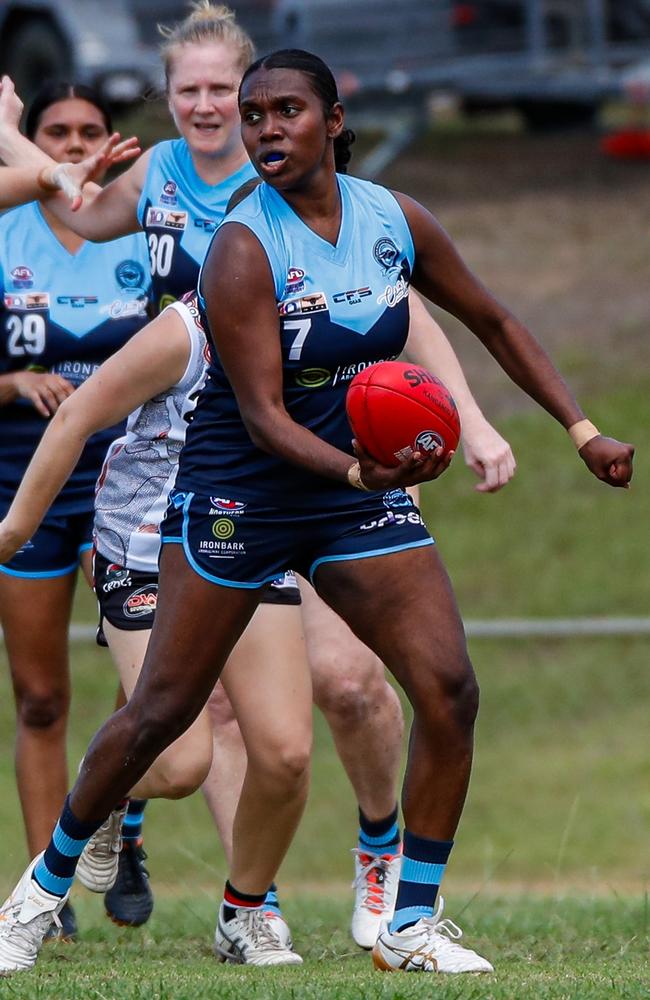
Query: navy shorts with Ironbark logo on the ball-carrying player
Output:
[[161, 487, 433, 588]]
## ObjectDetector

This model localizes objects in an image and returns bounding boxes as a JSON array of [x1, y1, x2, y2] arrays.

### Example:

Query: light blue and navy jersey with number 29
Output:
[[0, 203, 149, 514]]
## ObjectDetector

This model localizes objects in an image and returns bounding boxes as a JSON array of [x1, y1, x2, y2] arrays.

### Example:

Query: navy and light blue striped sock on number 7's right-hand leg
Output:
[[390, 830, 454, 934]]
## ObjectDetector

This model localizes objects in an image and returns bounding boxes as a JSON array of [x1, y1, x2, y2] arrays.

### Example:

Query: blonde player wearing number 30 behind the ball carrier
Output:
[[0, 3, 514, 947]]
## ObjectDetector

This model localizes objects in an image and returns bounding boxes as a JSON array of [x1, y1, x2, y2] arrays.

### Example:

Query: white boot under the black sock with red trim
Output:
[[214, 904, 302, 965]]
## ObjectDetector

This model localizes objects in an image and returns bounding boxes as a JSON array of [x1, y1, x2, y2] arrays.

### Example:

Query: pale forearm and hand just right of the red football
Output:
[[405, 290, 517, 493]]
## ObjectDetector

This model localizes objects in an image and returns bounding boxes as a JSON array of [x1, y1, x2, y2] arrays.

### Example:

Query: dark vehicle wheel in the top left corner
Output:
[[3, 19, 72, 104]]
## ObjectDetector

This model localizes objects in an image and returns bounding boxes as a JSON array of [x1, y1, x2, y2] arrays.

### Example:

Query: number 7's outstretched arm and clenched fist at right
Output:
[[396, 194, 634, 486]]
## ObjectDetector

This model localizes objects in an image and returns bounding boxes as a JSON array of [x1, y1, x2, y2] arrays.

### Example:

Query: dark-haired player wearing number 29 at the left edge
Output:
[[0, 80, 149, 937]]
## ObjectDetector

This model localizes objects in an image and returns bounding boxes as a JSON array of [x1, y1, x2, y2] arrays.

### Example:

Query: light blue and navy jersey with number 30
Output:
[[138, 139, 257, 314]]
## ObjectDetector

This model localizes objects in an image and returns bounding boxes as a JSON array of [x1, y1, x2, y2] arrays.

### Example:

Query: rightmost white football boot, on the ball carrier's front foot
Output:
[[372, 897, 494, 973]]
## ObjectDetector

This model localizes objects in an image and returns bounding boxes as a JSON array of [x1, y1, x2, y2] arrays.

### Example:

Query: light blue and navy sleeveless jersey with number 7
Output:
[[176, 176, 414, 506]]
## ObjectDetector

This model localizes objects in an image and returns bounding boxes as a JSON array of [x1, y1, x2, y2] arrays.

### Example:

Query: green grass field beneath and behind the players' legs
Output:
[[0, 385, 650, 1000]]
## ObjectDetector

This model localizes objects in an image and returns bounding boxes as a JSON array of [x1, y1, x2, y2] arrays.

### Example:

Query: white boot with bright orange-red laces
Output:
[[351, 847, 402, 949]]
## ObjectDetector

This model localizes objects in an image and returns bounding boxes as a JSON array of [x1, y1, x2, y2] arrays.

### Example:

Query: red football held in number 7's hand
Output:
[[345, 361, 460, 466]]
